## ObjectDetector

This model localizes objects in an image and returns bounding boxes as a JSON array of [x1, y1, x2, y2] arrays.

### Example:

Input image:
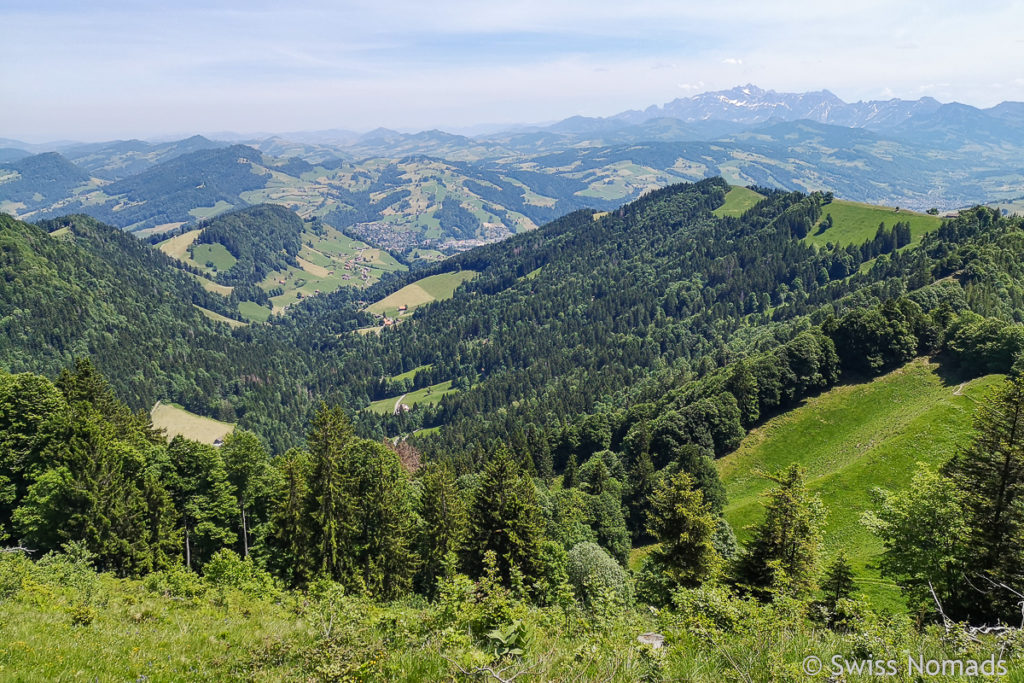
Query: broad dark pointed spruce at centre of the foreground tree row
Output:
[[467, 447, 543, 581]]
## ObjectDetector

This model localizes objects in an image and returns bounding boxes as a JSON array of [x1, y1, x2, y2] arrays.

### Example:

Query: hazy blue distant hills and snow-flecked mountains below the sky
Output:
[[0, 85, 1024, 253]]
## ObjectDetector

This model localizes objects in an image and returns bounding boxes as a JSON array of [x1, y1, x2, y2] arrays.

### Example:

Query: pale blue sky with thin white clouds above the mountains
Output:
[[0, 0, 1024, 142]]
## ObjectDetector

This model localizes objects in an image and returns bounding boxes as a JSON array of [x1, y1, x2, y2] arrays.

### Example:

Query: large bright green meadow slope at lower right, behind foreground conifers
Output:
[[718, 359, 999, 604]]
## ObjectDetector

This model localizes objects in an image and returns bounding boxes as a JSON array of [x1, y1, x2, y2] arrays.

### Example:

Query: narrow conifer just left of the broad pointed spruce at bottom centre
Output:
[[417, 463, 467, 594]]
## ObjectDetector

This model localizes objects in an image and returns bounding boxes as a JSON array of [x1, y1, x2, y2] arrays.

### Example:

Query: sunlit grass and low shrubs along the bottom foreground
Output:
[[0, 553, 1022, 683]]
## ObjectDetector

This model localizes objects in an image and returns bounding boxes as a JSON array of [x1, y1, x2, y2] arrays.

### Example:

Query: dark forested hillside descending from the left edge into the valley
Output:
[[0, 216, 344, 443]]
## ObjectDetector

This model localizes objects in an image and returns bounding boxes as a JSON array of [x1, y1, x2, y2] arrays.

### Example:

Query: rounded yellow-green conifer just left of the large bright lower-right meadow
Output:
[[647, 472, 721, 587]]
